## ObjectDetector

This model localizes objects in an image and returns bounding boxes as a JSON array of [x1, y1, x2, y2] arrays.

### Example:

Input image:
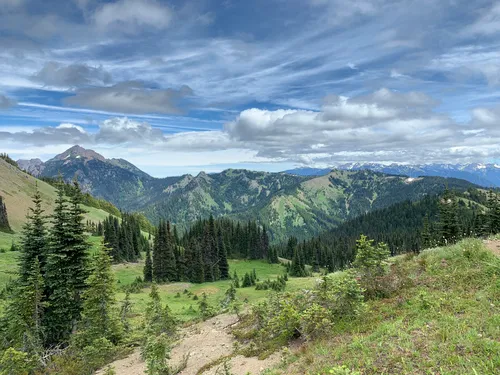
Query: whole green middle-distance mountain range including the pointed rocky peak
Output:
[[18, 146, 474, 240]]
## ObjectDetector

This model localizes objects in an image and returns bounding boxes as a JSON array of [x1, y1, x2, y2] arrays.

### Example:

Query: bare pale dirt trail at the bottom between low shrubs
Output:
[[97, 314, 281, 375]]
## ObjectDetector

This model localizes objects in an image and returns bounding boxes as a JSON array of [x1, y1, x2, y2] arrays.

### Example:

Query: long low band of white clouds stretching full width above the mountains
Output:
[[0, 89, 500, 165]]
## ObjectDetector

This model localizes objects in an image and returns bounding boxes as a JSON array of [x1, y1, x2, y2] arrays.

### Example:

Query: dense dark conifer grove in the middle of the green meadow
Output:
[[144, 216, 278, 283]]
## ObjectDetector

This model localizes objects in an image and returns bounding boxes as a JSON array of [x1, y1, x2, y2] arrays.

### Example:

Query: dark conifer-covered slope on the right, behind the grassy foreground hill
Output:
[[271, 189, 500, 276]]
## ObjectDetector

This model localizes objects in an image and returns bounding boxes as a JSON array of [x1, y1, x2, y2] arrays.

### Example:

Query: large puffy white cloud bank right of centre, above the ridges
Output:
[[225, 89, 486, 163]]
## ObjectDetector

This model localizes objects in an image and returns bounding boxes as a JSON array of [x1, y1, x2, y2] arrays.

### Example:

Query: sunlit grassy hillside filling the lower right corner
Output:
[[270, 240, 500, 375]]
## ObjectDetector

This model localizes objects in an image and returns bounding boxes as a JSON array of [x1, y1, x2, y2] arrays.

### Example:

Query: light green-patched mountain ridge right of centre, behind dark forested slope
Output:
[[252, 171, 473, 239]]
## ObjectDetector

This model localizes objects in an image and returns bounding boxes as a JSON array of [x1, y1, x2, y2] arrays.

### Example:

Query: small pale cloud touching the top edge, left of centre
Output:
[[92, 0, 172, 34]]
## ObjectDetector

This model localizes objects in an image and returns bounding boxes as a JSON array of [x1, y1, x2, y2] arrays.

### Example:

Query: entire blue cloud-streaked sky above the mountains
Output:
[[0, 0, 500, 176]]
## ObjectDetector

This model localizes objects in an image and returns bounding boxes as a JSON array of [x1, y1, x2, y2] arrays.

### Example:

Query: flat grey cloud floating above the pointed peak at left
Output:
[[65, 81, 193, 114]]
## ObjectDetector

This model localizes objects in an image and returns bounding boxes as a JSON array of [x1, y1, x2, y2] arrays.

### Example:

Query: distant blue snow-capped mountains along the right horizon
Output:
[[285, 163, 500, 187]]
